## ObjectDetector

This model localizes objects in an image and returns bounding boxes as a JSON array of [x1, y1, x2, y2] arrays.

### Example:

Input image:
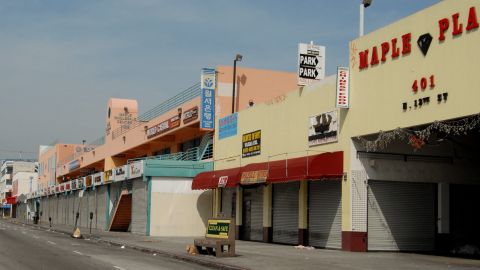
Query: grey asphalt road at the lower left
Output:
[[0, 218, 212, 270]]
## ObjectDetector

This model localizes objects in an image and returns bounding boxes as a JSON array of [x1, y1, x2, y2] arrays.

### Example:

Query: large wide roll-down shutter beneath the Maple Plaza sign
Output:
[[368, 181, 436, 251]]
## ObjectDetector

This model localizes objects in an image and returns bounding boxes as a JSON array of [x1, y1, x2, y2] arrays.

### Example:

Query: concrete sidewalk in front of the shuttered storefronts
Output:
[[8, 220, 480, 270]]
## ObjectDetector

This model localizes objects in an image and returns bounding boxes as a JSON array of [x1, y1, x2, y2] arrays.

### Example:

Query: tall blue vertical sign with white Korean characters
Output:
[[200, 68, 216, 130]]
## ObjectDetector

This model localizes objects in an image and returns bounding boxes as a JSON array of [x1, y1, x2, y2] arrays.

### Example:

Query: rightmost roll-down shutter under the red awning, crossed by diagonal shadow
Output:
[[308, 181, 342, 248]]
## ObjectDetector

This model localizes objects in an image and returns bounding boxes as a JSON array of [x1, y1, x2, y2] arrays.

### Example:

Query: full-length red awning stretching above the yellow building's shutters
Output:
[[192, 151, 343, 189]]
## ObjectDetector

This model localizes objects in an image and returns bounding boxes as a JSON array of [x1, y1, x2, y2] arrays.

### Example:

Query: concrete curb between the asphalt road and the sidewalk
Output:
[[10, 220, 249, 270]]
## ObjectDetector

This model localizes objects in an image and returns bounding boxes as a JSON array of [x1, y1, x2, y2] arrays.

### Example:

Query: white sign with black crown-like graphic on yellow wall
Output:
[[308, 111, 338, 146]]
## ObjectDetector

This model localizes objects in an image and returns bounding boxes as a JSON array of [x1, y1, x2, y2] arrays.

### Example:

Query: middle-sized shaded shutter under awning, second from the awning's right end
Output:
[[272, 182, 300, 245]]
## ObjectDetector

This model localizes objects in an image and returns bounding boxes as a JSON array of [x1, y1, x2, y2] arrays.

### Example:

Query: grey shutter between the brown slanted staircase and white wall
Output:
[[131, 178, 147, 234]]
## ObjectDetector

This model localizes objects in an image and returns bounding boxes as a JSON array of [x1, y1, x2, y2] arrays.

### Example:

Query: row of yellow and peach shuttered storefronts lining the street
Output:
[[21, 0, 480, 252]]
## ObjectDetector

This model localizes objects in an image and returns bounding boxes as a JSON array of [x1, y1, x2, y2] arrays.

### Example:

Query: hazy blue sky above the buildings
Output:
[[0, 0, 439, 158]]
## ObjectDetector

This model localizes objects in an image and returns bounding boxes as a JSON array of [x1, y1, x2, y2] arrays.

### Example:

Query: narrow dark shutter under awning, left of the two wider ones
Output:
[[242, 186, 263, 241]]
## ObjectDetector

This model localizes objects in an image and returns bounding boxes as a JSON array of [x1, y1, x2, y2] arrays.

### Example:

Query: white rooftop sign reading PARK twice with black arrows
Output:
[[298, 43, 325, 86]]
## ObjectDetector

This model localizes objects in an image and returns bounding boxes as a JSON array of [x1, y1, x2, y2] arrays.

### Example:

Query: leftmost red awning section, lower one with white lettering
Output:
[[192, 168, 240, 189]]
